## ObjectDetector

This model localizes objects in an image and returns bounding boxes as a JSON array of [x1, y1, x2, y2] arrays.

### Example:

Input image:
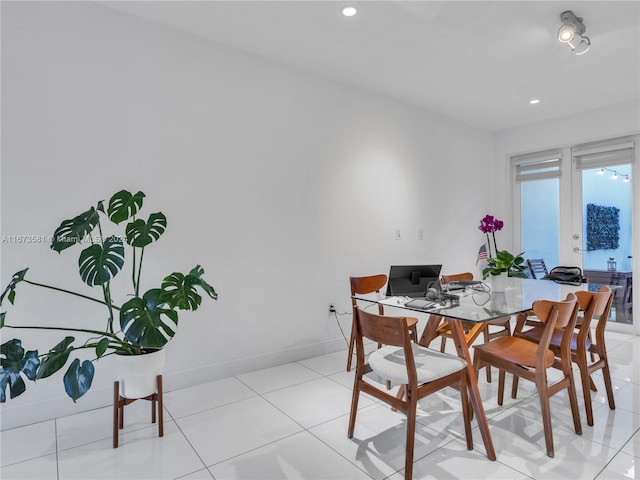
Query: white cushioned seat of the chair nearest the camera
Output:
[[369, 343, 467, 385]]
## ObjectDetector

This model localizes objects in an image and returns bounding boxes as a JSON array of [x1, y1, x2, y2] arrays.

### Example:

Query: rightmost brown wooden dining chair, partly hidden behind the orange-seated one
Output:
[[512, 285, 616, 426]]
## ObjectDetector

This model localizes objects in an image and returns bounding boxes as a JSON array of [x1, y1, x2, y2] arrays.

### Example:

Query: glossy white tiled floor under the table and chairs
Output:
[[0, 333, 640, 480]]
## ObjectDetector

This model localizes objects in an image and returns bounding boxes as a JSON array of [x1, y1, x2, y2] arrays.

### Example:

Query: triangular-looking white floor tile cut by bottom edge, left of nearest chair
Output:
[[210, 432, 370, 480]]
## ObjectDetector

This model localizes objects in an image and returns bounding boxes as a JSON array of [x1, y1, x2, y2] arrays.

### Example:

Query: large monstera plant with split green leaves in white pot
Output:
[[0, 190, 218, 402]]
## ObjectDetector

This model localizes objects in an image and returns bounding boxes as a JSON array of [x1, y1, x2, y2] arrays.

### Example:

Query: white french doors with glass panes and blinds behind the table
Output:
[[511, 133, 640, 333]]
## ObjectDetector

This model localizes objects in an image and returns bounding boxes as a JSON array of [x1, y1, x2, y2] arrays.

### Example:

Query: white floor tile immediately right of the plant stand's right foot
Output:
[[176, 397, 302, 466]]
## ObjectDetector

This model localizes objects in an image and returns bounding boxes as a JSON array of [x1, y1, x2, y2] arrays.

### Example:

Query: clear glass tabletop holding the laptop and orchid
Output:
[[353, 277, 596, 323]]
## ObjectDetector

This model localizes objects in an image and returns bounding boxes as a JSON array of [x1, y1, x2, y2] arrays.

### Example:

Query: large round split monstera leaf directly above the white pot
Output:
[[120, 288, 178, 348]]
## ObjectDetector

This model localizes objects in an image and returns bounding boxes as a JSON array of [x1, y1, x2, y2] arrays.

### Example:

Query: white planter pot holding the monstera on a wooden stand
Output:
[[116, 349, 165, 399]]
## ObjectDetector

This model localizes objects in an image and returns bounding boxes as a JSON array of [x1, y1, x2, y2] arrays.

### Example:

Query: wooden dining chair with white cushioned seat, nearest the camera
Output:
[[347, 307, 473, 480]]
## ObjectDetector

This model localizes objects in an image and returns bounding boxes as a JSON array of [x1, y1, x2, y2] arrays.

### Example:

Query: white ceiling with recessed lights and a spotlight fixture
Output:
[[101, 0, 640, 132]]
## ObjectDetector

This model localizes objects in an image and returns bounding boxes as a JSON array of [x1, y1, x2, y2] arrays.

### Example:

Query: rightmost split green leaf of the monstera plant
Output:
[[162, 265, 218, 310]]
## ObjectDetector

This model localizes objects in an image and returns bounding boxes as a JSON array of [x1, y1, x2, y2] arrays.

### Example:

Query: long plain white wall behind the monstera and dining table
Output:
[[0, 2, 493, 428]]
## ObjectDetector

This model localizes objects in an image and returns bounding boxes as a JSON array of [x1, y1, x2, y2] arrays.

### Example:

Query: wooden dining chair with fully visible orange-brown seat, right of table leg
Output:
[[473, 293, 582, 457]]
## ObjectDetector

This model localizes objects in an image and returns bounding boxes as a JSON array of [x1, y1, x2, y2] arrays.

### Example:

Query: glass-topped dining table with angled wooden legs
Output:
[[353, 277, 593, 460]]
